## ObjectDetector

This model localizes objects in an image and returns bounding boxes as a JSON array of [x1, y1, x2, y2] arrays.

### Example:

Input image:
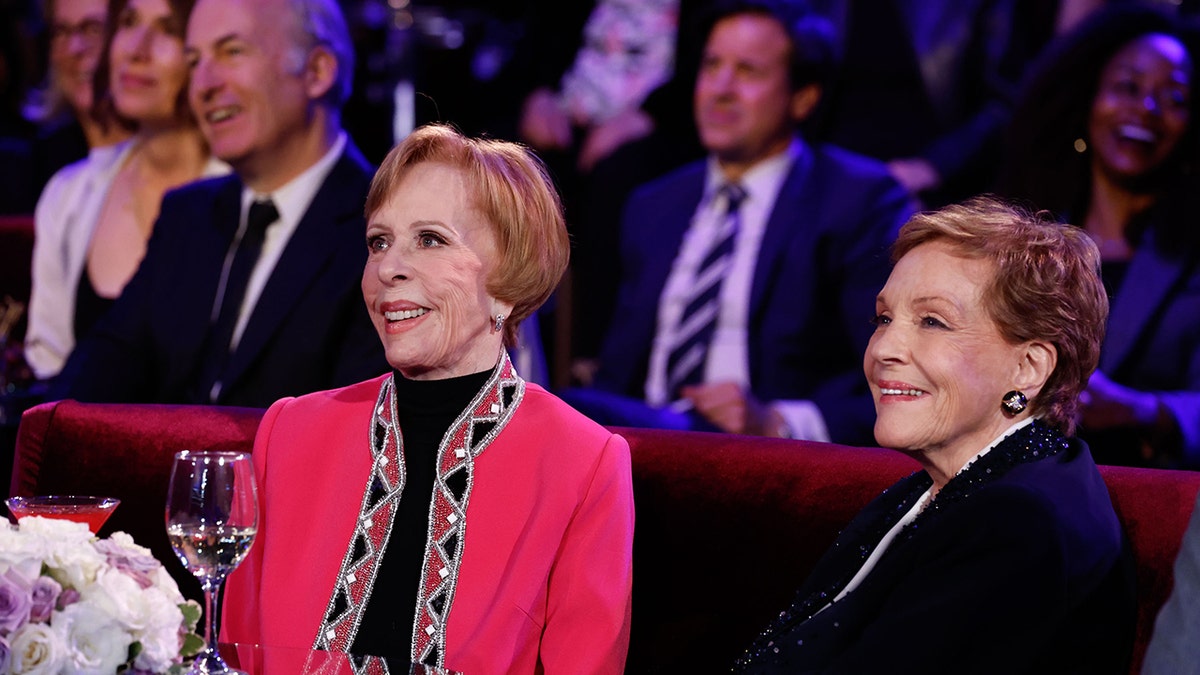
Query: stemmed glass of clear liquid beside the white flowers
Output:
[[167, 450, 258, 675]]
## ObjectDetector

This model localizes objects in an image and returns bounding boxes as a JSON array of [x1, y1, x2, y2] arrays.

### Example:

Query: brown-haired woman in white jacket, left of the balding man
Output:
[[25, 0, 229, 378]]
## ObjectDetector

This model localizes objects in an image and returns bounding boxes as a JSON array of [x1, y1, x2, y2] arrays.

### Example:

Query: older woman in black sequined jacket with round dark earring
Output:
[[738, 193, 1134, 674]]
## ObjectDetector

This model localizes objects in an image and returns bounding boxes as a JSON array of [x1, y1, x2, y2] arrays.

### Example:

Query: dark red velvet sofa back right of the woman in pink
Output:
[[618, 429, 1200, 674]]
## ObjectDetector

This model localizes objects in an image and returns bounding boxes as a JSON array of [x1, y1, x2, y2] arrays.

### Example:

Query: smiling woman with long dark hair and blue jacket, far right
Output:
[[998, 5, 1200, 466]]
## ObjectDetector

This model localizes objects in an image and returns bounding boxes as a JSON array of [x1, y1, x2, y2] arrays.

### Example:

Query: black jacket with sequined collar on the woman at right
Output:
[[734, 422, 1135, 674]]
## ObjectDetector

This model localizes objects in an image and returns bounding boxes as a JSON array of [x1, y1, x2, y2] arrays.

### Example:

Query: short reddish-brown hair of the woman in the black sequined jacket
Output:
[[892, 196, 1109, 434]]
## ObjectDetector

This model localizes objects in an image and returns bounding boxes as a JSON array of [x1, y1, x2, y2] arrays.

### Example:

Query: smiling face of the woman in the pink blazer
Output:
[[362, 162, 512, 380]]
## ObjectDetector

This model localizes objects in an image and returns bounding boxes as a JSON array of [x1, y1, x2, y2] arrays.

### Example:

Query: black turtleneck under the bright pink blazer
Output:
[[352, 370, 492, 662]]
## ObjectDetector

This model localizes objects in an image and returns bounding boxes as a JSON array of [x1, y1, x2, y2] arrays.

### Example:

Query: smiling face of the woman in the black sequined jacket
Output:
[[863, 240, 1024, 459]]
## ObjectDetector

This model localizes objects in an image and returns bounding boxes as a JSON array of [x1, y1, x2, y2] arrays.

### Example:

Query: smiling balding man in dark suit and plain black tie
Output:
[[56, 0, 388, 406]]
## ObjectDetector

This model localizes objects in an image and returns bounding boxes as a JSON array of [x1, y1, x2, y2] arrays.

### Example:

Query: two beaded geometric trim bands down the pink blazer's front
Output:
[[313, 351, 526, 665]]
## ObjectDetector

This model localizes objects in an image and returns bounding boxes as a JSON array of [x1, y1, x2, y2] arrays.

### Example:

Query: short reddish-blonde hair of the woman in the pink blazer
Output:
[[366, 124, 570, 346]]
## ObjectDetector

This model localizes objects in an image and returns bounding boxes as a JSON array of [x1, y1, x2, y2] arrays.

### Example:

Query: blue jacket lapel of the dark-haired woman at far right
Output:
[[1100, 231, 1192, 375]]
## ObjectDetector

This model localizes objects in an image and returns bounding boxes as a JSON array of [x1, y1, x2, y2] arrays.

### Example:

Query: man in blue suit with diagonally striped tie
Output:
[[568, 2, 912, 443]]
